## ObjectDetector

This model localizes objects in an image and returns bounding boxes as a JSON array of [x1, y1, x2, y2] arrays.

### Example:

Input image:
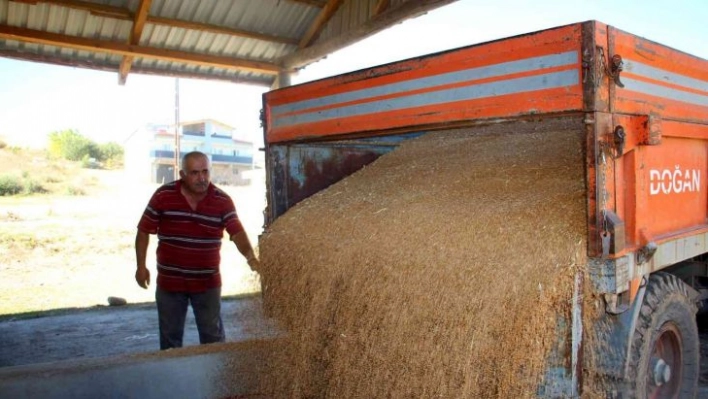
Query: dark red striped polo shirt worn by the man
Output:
[[138, 180, 243, 292]]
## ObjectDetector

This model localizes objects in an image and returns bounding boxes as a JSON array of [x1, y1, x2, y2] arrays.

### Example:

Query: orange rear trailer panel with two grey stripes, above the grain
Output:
[[265, 25, 583, 143]]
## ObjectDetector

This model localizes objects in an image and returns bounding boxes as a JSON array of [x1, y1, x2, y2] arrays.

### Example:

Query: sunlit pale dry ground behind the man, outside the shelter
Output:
[[0, 169, 265, 315]]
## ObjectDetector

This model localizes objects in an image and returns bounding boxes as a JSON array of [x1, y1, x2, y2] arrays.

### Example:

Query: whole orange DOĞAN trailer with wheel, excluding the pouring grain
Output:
[[263, 21, 708, 398]]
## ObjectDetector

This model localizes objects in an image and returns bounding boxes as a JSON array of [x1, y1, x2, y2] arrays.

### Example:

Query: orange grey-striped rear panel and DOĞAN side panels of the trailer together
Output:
[[264, 21, 708, 258]]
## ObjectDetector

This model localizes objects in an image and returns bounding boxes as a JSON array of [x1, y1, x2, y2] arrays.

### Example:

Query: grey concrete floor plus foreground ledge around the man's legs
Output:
[[0, 296, 277, 399]]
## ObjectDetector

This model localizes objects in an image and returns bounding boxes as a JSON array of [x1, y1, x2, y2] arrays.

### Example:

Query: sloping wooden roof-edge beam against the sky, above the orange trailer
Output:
[[279, 0, 457, 70]]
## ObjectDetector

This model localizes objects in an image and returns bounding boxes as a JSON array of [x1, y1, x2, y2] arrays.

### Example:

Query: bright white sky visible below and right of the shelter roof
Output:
[[0, 0, 708, 147]]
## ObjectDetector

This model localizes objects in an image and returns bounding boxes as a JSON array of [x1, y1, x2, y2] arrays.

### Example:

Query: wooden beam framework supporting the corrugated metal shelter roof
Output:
[[0, 0, 455, 84]]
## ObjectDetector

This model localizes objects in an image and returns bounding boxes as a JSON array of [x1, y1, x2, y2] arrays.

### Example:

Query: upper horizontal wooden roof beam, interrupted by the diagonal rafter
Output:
[[10, 0, 298, 45]]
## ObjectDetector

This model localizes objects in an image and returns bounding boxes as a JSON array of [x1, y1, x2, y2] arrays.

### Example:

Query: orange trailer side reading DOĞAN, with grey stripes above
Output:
[[598, 27, 708, 256]]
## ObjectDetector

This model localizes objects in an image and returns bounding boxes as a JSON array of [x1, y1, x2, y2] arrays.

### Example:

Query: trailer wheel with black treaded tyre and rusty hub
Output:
[[628, 273, 700, 399]]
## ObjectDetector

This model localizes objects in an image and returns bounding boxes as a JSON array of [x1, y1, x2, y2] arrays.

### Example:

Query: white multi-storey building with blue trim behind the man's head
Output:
[[125, 119, 255, 185]]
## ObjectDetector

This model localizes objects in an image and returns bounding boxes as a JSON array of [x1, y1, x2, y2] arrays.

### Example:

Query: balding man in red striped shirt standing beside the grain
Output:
[[135, 152, 259, 349]]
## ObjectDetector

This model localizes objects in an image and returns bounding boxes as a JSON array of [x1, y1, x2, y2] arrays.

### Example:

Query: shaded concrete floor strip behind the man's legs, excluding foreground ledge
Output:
[[0, 295, 276, 367]]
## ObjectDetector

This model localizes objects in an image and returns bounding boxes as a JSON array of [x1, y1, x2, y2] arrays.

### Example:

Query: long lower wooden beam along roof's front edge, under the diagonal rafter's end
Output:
[[0, 25, 281, 75]]
